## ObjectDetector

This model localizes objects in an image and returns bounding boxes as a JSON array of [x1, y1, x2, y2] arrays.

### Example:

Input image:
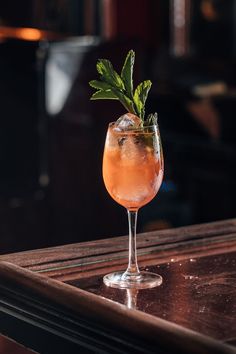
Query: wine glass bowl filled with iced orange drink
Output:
[[103, 126, 163, 210]]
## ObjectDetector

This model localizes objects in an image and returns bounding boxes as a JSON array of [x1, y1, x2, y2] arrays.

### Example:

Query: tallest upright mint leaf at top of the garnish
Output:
[[121, 50, 135, 98]]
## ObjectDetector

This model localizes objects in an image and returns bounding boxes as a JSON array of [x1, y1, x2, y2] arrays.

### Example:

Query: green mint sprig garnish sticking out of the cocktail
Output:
[[89, 50, 157, 125]]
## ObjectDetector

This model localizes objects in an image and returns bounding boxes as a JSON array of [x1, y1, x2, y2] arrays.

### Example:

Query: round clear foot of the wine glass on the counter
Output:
[[103, 271, 162, 289]]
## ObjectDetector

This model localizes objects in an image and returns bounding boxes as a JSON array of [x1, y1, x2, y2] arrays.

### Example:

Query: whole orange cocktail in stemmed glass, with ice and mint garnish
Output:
[[90, 50, 164, 289]]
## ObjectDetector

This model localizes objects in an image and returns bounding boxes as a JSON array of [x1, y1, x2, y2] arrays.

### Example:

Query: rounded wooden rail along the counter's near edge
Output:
[[0, 262, 236, 354]]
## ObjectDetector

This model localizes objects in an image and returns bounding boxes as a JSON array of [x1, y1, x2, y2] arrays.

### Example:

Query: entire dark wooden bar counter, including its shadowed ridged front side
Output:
[[0, 219, 236, 354]]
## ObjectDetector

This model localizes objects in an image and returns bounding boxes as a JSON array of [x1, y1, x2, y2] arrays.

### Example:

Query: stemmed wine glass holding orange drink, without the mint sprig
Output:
[[103, 122, 164, 289]]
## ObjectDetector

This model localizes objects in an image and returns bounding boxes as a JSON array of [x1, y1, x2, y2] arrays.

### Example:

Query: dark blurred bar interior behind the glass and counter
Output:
[[0, 0, 236, 253]]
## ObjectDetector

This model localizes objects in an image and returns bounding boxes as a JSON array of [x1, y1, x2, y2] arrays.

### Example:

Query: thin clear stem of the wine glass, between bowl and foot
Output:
[[125, 210, 140, 276]]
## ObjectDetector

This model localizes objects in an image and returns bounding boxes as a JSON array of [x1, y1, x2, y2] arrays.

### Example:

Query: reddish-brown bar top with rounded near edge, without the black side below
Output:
[[0, 219, 236, 353]]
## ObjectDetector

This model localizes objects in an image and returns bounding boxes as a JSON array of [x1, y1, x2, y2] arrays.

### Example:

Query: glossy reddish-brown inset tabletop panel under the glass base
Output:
[[70, 250, 236, 341]]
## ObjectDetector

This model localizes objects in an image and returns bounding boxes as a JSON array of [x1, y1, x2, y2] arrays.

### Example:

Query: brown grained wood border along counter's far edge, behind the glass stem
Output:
[[0, 219, 236, 273]]
